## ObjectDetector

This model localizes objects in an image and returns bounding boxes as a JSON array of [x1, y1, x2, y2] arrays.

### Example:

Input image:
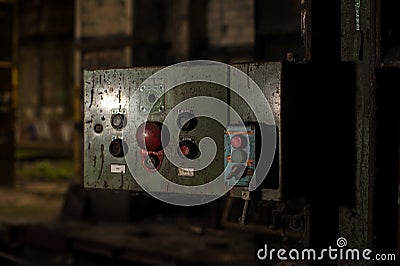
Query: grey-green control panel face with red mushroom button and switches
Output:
[[84, 62, 300, 200]]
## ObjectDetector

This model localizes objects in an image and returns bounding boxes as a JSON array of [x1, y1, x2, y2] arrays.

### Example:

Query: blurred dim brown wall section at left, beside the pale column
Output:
[[16, 0, 73, 143]]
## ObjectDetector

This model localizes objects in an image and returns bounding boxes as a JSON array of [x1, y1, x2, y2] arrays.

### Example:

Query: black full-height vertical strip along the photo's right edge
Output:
[[373, 1, 400, 260]]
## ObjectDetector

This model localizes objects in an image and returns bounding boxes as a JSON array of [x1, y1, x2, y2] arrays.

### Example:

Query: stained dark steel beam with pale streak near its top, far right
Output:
[[339, 0, 381, 265]]
